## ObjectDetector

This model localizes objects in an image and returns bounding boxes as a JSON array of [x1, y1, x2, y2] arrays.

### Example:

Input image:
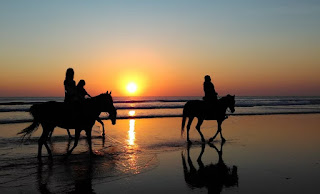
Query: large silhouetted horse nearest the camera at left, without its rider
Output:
[[18, 92, 117, 159]]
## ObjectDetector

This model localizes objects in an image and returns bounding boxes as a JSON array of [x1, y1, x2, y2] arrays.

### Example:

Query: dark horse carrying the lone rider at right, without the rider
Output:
[[181, 94, 235, 143]]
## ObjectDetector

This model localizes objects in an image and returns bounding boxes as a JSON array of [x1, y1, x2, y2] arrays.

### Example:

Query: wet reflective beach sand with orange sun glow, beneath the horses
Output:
[[0, 114, 320, 193]]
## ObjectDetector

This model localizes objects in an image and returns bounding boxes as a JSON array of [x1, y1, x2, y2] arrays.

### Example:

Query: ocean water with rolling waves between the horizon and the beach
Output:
[[0, 96, 320, 124]]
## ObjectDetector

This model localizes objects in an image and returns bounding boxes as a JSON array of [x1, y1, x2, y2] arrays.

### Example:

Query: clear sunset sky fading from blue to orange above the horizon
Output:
[[0, 0, 320, 97]]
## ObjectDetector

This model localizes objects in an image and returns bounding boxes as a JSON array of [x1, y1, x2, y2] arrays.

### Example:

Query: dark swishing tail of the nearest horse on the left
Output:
[[17, 105, 40, 141]]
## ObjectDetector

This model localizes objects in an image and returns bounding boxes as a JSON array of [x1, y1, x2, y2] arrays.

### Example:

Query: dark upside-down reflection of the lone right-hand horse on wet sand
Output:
[[181, 142, 238, 193]]
